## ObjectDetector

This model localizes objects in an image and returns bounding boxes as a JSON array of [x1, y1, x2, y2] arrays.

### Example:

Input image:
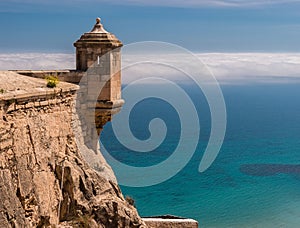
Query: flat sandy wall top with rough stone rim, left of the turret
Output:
[[0, 72, 79, 118]]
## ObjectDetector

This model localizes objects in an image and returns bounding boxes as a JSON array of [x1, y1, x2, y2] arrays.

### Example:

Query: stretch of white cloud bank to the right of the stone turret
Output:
[[123, 53, 300, 83]]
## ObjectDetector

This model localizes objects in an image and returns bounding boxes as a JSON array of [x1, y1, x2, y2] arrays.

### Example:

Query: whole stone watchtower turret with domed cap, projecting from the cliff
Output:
[[74, 18, 124, 148]]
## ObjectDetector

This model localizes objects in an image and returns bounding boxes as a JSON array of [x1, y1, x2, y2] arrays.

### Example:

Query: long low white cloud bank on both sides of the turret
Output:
[[0, 53, 300, 83]]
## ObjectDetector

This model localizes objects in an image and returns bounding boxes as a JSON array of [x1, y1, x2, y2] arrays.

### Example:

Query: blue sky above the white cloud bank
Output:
[[0, 0, 300, 53]]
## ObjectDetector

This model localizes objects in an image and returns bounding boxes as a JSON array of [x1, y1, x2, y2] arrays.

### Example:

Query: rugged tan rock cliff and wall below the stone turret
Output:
[[0, 72, 144, 227]]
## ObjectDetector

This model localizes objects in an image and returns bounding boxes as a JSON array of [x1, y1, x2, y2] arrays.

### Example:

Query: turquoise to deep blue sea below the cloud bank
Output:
[[101, 83, 300, 227]]
